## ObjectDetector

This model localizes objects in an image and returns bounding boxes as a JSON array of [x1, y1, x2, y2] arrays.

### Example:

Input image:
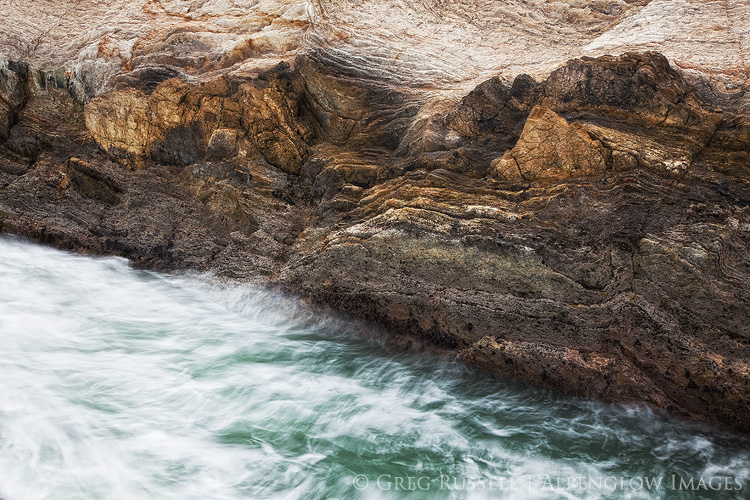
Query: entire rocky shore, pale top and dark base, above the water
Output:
[[0, 0, 750, 431]]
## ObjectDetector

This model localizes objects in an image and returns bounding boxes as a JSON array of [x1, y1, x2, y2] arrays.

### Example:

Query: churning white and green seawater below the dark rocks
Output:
[[0, 238, 750, 500]]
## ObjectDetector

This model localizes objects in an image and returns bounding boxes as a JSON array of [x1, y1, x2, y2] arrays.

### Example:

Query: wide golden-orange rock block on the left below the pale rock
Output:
[[85, 66, 314, 173]]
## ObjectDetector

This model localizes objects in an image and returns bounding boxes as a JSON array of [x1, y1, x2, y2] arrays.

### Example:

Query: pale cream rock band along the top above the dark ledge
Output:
[[0, 0, 750, 106]]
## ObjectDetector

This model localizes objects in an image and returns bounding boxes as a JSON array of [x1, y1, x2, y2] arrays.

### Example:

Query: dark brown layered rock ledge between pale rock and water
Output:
[[0, 52, 750, 431]]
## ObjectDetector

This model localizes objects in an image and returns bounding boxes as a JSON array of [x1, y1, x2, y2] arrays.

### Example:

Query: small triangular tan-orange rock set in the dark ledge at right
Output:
[[492, 106, 607, 181]]
